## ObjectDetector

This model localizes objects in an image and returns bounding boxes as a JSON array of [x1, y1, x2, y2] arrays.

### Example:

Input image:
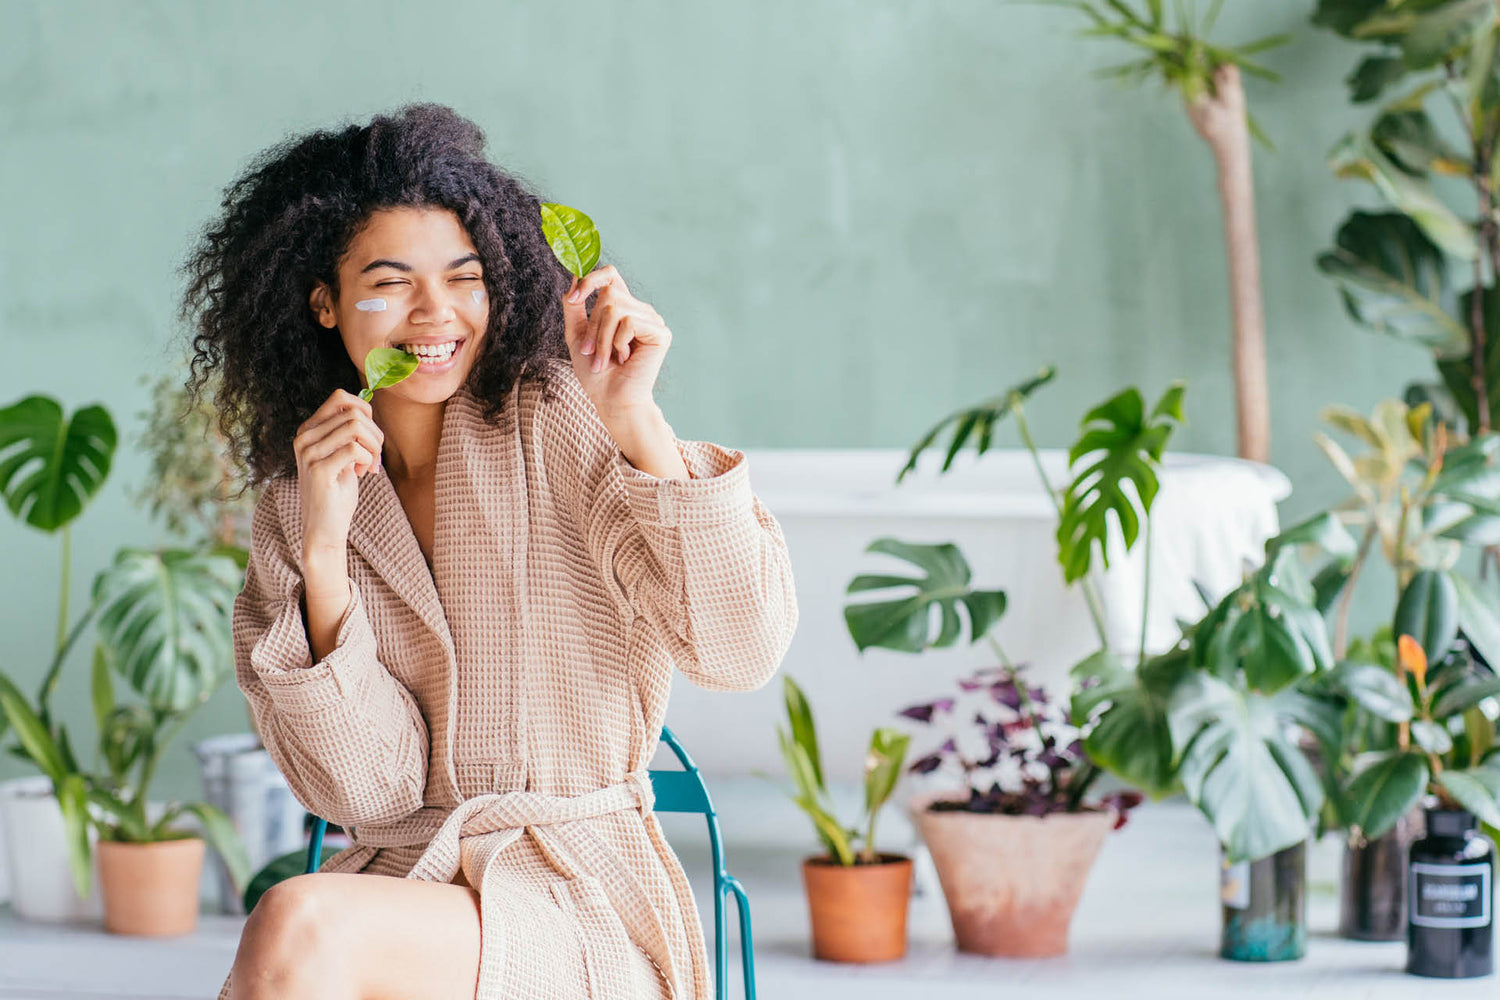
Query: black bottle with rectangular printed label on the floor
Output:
[[1407, 808, 1496, 979]]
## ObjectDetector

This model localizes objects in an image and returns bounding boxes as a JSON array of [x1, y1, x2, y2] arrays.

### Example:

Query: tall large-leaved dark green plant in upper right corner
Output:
[[1313, 0, 1500, 433]]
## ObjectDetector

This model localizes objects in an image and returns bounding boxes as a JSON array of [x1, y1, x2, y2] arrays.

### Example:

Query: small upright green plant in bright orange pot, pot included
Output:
[[777, 676, 912, 963]]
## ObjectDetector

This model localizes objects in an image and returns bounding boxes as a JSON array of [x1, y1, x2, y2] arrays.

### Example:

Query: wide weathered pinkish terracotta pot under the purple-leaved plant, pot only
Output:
[[912, 796, 1115, 958]]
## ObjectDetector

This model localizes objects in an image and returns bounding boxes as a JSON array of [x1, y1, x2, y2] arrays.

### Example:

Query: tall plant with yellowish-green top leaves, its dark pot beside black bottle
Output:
[[1316, 400, 1500, 940]]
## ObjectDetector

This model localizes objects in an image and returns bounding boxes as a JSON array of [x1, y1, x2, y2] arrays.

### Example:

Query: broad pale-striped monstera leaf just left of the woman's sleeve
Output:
[[93, 549, 243, 712]]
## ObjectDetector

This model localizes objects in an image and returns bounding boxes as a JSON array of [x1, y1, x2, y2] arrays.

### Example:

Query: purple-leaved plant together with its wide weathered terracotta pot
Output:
[[902, 664, 1142, 958]]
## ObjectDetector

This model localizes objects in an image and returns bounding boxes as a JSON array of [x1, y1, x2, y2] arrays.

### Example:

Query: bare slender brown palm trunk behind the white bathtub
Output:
[[1188, 63, 1271, 462]]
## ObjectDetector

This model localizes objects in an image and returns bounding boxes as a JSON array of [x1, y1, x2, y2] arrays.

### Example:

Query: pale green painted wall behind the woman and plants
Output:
[[0, 0, 1427, 793]]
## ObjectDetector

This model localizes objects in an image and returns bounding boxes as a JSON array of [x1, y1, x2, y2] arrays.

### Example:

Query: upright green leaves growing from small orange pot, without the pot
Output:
[[777, 676, 911, 865]]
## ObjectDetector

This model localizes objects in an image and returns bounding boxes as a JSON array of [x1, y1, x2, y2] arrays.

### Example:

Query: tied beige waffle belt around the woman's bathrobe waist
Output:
[[351, 771, 678, 996]]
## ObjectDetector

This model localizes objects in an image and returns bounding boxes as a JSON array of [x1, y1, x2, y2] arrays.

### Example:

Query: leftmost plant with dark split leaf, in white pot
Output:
[[0, 396, 116, 921]]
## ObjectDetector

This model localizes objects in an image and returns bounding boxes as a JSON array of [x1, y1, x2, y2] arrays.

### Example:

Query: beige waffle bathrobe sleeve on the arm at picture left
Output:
[[233, 480, 428, 826]]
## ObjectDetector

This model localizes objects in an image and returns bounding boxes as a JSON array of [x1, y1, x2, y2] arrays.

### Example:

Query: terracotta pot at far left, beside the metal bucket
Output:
[[99, 837, 204, 937]]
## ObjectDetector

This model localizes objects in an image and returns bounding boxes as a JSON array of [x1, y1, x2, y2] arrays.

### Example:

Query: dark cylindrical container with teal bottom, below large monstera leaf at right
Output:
[[1220, 841, 1308, 963]]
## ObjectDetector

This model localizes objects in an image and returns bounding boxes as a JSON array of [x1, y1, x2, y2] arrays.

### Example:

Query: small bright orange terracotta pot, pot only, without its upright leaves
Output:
[[803, 855, 912, 963]]
